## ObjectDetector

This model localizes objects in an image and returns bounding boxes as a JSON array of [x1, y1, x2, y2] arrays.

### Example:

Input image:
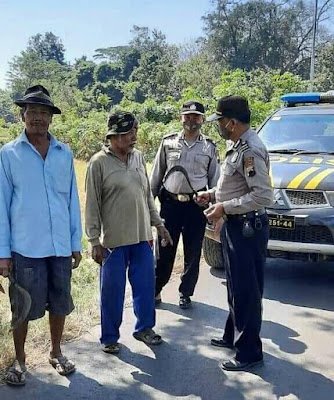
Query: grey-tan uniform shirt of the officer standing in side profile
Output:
[[215, 129, 273, 214]]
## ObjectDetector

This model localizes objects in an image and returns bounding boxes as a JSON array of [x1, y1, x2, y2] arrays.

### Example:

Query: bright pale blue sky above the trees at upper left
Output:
[[0, 0, 212, 88]]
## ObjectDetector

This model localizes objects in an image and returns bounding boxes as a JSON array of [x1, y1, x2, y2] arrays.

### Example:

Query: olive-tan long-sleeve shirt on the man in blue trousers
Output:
[[85, 146, 162, 248]]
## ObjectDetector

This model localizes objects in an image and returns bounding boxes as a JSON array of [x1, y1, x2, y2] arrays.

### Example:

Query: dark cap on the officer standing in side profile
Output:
[[207, 96, 250, 122]]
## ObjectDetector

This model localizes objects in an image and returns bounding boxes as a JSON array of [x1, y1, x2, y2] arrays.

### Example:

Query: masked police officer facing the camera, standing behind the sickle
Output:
[[151, 101, 219, 308]]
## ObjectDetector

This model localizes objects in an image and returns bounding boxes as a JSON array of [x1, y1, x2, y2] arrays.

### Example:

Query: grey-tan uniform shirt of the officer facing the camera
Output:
[[151, 132, 219, 197]]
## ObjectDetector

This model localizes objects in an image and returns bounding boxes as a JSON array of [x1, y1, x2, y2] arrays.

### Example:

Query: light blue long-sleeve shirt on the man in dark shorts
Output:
[[0, 131, 82, 258]]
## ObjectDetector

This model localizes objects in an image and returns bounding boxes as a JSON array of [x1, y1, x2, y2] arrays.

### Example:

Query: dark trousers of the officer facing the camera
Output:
[[155, 192, 206, 297]]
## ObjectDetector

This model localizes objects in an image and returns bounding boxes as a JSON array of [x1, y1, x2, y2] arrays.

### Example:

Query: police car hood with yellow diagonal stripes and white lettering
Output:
[[270, 154, 334, 190]]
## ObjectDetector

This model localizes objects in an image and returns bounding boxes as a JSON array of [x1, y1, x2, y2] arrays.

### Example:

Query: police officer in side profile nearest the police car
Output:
[[197, 96, 273, 371]]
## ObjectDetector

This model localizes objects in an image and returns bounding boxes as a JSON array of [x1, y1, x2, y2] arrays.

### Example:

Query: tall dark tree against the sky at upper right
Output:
[[203, 0, 331, 76]]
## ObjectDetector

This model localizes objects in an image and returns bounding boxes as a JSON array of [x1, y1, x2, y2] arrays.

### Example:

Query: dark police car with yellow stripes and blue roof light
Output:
[[203, 91, 334, 268]]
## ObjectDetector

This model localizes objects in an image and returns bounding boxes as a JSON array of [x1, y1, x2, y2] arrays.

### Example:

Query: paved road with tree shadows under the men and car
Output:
[[0, 260, 334, 400]]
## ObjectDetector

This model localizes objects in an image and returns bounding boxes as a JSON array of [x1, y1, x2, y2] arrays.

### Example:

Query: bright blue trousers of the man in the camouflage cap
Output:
[[100, 242, 155, 344]]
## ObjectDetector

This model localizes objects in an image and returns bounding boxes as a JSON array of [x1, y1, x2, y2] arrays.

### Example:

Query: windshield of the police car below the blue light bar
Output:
[[258, 114, 334, 154]]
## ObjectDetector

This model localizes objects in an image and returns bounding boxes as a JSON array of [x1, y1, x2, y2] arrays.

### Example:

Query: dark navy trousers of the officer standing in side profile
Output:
[[221, 214, 269, 362]]
